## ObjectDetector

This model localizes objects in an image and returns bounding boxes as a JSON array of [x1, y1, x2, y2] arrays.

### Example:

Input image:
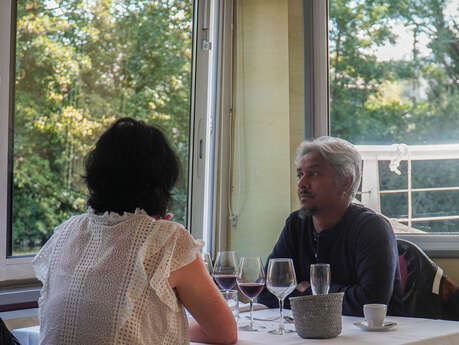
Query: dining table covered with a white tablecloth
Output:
[[13, 309, 459, 345]]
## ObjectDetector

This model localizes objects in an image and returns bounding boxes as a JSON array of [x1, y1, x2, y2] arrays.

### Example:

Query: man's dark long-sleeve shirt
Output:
[[258, 204, 400, 316]]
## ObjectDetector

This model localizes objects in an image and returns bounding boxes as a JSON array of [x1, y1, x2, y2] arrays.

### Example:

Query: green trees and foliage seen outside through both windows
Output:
[[11, 0, 459, 254]]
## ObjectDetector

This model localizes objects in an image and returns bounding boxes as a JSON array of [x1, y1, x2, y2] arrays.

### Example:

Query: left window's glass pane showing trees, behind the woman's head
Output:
[[10, 0, 193, 255]]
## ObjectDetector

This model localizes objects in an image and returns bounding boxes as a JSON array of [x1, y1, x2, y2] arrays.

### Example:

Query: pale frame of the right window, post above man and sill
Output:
[[312, 0, 459, 258]]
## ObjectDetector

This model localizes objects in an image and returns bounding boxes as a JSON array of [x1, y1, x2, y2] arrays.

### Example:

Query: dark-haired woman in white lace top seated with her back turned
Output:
[[34, 118, 237, 345]]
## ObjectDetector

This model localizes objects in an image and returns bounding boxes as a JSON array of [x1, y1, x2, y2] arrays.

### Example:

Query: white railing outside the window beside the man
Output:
[[356, 144, 459, 228]]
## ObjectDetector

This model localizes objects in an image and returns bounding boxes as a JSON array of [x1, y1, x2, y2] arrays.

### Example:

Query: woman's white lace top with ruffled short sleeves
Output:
[[34, 210, 202, 345]]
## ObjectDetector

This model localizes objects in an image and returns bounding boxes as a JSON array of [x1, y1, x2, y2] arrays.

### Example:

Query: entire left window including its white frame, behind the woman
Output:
[[0, 0, 216, 280]]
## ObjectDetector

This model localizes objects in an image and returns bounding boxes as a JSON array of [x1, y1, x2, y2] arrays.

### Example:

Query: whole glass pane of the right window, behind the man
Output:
[[329, 0, 459, 232]]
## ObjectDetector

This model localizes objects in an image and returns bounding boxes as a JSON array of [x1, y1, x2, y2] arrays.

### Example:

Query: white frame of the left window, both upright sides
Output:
[[0, 0, 217, 282]]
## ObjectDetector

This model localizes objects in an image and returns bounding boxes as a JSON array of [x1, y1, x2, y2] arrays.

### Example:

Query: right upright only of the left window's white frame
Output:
[[187, 0, 221, 252]]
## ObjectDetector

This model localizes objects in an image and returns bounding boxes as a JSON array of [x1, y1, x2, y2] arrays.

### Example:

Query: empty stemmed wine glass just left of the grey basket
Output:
[[266, 258, 296, 335]]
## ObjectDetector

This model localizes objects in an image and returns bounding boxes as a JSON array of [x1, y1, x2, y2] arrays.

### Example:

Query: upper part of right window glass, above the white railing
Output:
[[330, 0, 459, 144]]
